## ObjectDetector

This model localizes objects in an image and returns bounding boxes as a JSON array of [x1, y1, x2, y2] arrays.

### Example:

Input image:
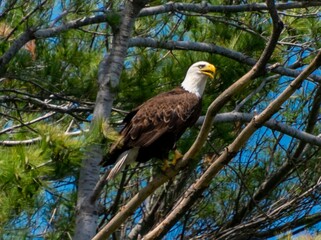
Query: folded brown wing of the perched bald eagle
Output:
[[121, 88, 201, 147]]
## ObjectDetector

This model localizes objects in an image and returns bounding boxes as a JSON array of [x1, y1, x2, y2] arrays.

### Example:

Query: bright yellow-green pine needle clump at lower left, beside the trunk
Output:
[[0, 125, 84, 236]]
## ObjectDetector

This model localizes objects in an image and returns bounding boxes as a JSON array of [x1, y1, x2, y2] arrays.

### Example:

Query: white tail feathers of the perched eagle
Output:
[[107, 148, 139, 180]]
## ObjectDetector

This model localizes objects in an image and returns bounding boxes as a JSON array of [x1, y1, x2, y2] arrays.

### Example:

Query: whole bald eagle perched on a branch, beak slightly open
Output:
[[101, 61, 216, 180]]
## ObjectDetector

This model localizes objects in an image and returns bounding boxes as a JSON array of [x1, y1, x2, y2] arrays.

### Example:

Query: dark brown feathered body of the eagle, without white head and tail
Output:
[[102, 87, 202, 166]]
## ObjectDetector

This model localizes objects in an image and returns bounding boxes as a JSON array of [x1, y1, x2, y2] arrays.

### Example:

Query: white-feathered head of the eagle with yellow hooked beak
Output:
[[181, 61, 216, 97]]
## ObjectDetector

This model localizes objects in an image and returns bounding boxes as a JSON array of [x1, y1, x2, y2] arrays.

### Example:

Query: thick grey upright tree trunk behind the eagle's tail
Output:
[[74, 1, 147, 240]]
